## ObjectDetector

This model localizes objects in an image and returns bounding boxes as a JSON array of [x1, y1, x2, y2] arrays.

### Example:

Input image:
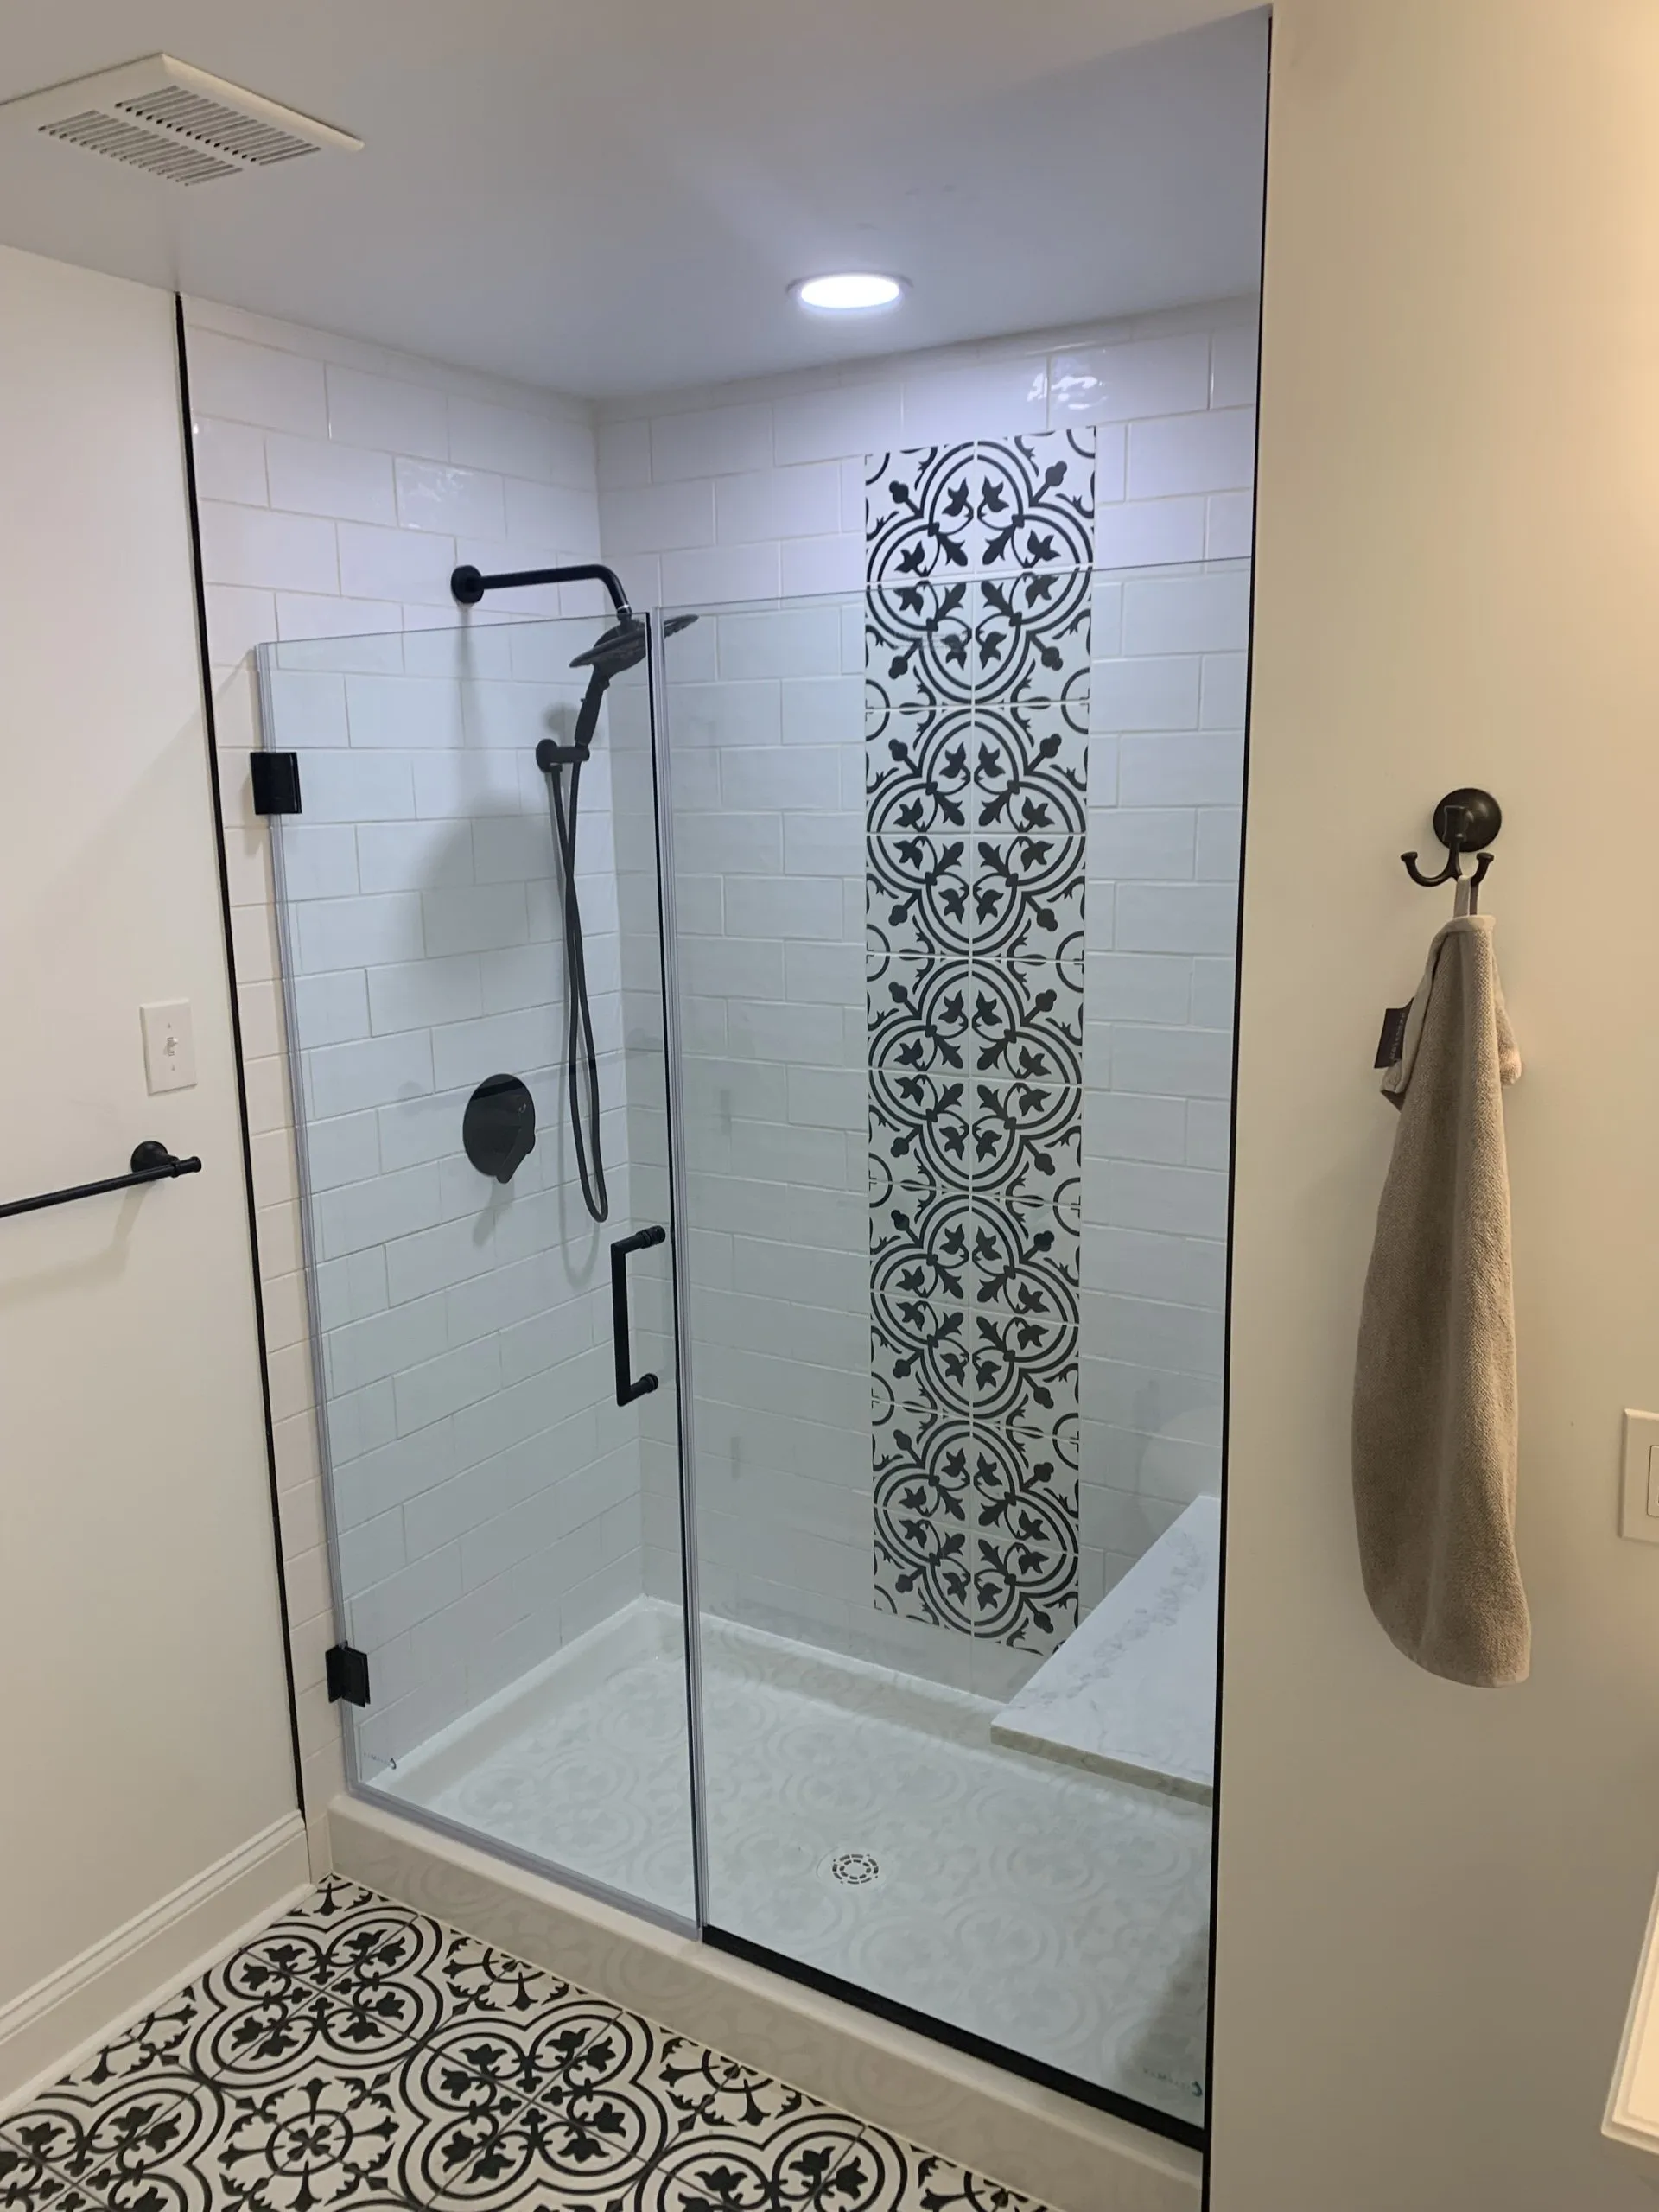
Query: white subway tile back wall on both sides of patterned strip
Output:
[[600, 301, 1256, 1692]]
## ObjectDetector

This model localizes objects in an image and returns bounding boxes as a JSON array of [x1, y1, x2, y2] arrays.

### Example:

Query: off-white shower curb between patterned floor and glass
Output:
[[327, 1794, 1204, 2212]]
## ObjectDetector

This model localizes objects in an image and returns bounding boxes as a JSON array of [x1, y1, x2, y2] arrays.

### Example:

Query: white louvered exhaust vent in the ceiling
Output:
[[0, 53, 363, 183]]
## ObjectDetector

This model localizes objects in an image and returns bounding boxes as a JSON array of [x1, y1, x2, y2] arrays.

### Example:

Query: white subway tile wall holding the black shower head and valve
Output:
[[186, 301, 610, 1872]]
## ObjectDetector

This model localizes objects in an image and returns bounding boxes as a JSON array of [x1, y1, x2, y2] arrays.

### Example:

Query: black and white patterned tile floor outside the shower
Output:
[[0, 1880, 1039, 2212]]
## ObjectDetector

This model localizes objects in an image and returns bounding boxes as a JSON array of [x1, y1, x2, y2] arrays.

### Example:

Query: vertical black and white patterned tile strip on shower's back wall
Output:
[[865, 429, 1095, 1652]]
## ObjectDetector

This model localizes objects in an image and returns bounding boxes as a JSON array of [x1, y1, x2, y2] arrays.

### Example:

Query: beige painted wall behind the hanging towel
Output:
[[1212, 0, 1659, 2212]]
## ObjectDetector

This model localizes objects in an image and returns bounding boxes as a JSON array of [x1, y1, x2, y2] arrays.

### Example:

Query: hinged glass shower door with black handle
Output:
[[261, 620, 696, 1923]]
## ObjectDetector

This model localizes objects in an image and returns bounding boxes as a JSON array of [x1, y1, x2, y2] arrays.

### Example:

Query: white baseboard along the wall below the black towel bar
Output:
[[0, 1812, 309, 2110]]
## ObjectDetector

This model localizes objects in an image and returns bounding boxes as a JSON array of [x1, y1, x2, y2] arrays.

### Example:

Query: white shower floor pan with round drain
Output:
[[376, 1599, 1210, 2121]]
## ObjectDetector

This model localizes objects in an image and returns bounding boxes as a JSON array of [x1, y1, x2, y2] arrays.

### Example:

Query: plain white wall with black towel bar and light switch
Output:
[[0, 250, 303, 2094]]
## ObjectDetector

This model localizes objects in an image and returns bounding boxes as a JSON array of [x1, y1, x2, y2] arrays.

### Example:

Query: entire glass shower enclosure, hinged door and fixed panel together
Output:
[[261, 562, 1248, 2141]]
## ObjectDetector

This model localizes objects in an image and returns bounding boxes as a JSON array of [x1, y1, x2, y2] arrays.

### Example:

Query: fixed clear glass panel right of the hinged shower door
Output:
[[664, 562, 1248, 2134]]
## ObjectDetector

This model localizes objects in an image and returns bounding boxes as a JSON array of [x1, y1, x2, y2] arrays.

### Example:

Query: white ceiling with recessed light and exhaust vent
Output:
[[0, 0, 1268, 396]]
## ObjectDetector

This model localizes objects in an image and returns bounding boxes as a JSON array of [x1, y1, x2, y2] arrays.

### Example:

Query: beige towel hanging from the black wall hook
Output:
[[1354, 913, 1531, 1688]]
